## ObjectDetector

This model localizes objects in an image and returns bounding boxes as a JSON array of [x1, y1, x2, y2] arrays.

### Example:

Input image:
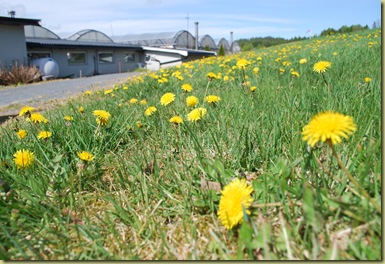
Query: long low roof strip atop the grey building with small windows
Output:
[[26, 38, 142, 50]]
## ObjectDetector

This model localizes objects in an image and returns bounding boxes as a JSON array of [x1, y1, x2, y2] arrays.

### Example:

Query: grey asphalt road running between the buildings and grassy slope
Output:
[[0, 72, 141, 118]]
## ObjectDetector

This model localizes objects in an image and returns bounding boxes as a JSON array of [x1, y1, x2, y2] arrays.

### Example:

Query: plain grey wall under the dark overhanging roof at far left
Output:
[[0, 25, 27, 66]]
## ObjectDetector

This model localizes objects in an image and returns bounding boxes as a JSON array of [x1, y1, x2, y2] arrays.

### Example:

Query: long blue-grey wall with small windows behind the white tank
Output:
[[28, 48, 143, 78]]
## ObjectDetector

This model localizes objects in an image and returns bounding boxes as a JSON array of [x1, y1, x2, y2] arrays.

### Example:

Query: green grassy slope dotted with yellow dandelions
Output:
[[0, 30, 382, 260]]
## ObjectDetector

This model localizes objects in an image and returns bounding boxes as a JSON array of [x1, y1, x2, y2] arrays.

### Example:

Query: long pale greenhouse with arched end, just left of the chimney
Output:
[[112, 30, 195, 49]]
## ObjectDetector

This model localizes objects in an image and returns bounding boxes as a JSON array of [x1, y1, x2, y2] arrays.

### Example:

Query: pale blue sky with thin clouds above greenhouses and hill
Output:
[[0, 0, 381, 40]]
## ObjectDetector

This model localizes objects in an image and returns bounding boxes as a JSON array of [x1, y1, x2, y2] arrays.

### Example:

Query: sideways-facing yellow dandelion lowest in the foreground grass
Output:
[[218, 179, 254, 230]]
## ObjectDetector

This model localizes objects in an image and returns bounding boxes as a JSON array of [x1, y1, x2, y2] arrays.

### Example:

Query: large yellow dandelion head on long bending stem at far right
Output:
[[302, 111, 357, 147]]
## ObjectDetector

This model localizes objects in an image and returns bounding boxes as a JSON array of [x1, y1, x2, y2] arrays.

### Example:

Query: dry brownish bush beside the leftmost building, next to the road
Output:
[[0, 64, 41, 85]]
